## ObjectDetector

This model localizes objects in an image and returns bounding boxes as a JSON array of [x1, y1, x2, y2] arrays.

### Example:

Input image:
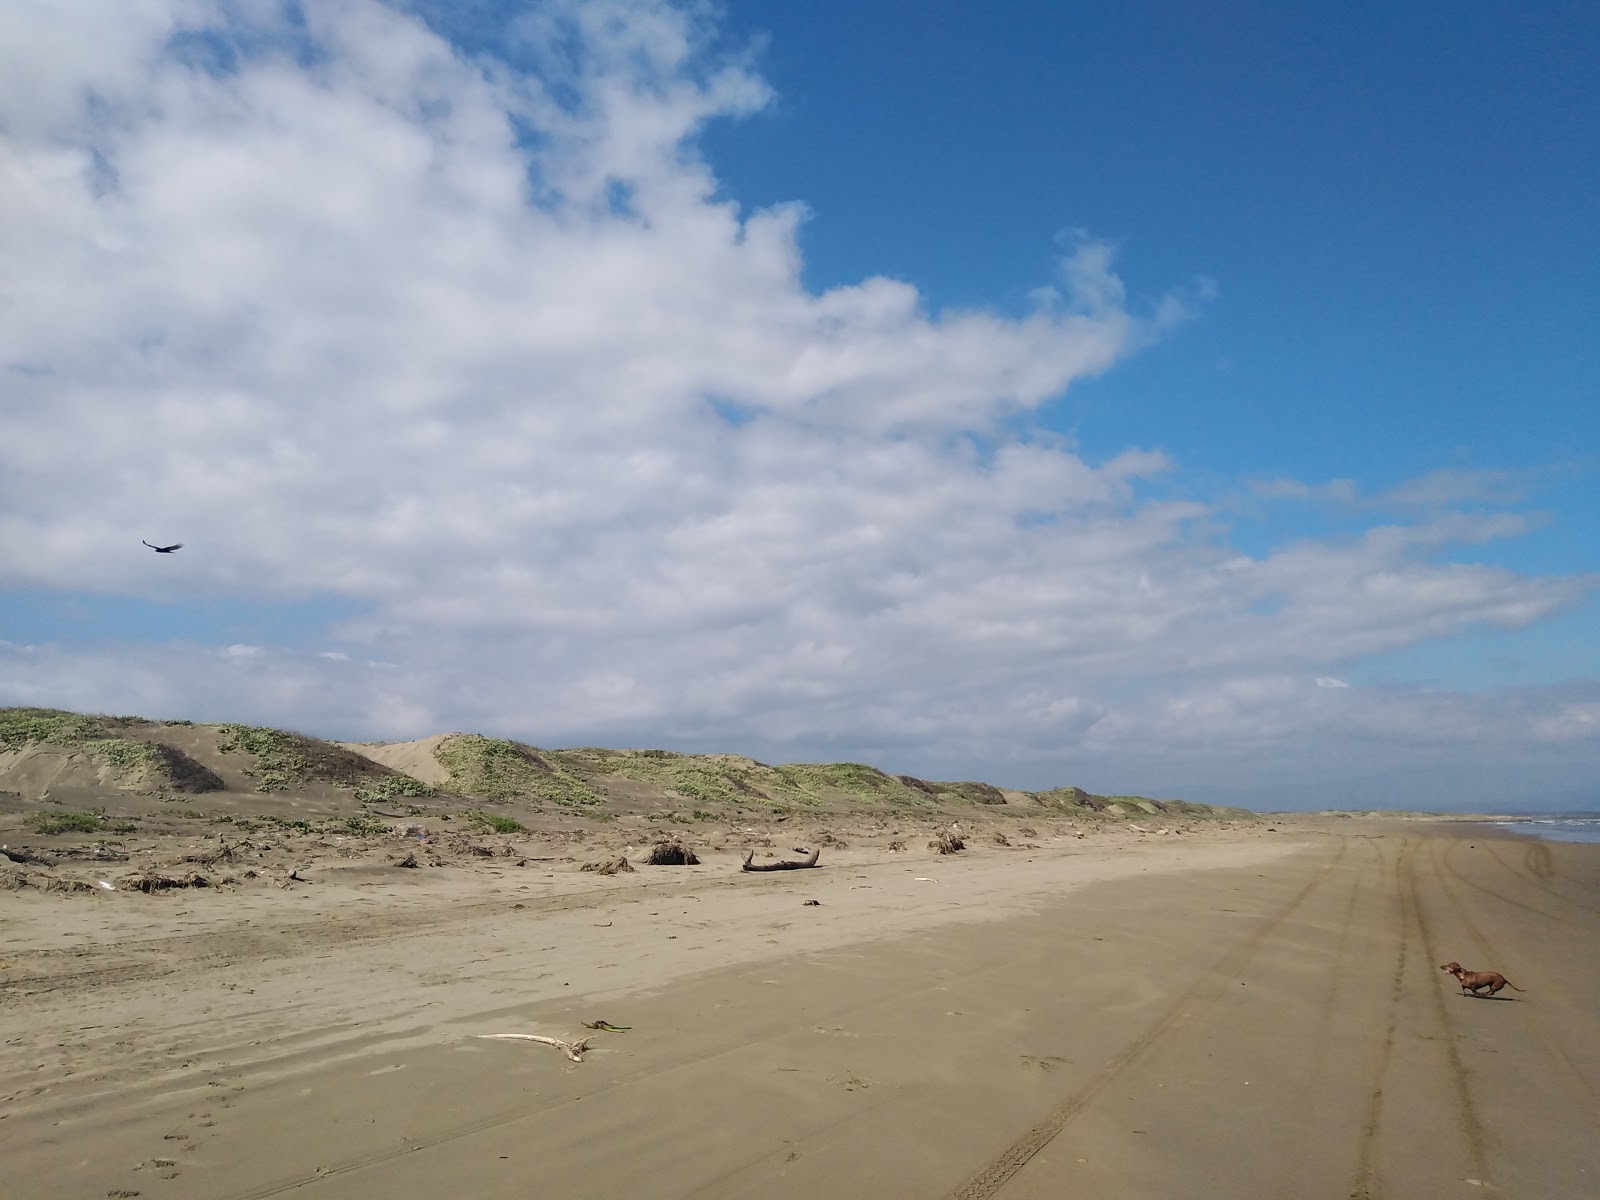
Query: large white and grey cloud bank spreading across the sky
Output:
[[0, 0, 1590, 812]]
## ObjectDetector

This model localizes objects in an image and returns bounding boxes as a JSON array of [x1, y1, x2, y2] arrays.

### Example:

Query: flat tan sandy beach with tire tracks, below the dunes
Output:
[[0, 822, 1600, 1200]]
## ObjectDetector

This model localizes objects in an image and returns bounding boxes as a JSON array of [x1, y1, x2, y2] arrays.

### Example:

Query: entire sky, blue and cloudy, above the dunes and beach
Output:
[[0, 0, 1600, 811]]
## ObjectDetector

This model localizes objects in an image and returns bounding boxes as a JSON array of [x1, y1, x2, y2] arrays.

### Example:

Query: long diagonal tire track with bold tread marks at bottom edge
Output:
[[952, 842, 1347, 1200]]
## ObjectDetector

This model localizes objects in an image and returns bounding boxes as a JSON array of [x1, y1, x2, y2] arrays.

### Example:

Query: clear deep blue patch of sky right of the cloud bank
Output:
[[706, 3, 1600, 499]]
